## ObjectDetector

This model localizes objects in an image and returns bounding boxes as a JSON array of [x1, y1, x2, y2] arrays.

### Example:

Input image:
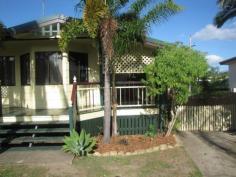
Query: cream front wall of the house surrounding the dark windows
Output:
[[0, 40, 99, 109]]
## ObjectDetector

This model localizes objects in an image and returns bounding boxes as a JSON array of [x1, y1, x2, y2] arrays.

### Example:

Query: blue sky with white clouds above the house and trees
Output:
[[0, 0, 236, 71]]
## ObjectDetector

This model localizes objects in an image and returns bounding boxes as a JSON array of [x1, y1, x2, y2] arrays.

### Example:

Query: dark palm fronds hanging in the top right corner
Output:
[[214, 0, 236, 28]]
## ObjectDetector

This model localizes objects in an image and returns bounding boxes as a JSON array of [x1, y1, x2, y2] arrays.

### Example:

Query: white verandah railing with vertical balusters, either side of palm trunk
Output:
[[77, 86, 155, 111]]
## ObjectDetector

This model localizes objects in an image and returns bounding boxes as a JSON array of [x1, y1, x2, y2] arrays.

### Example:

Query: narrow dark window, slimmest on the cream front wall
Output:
[[20, 53, 30, 85]]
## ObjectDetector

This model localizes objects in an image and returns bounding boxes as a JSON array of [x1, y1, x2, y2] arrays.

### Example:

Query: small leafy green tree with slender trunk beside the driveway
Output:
[[144, 44, 208, 136]]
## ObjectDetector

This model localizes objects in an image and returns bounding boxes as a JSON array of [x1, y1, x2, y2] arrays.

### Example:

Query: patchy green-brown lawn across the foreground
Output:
[[0, 148, 202, 177]]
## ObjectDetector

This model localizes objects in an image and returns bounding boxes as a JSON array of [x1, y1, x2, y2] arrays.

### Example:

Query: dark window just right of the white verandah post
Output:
[[69, 52, 88, 83]]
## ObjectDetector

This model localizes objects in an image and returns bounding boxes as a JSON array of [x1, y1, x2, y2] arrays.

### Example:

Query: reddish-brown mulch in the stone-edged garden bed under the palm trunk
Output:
[[95, 135, 176, 153]]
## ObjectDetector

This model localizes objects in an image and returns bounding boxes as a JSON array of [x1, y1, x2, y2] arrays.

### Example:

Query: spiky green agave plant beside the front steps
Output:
[[63, 129, 96, 156]]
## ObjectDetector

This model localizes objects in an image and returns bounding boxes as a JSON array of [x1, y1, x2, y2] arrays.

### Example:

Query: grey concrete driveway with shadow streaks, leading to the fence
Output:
[[179, 132, 236, 177]]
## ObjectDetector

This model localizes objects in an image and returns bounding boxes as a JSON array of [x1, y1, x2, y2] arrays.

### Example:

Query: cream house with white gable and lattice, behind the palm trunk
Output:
[[0, 15, 157, 121]]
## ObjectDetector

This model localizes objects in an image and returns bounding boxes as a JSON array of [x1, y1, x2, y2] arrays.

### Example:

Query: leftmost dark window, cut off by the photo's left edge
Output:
[[0, 56, 15, 86]]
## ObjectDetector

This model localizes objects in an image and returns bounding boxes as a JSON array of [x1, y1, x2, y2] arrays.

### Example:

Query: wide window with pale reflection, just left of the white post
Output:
[[35, 52, 62, 85]]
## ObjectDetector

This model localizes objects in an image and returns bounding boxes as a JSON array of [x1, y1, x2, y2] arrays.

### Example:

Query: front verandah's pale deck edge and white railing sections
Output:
[[1, 86, 156, 122]]
